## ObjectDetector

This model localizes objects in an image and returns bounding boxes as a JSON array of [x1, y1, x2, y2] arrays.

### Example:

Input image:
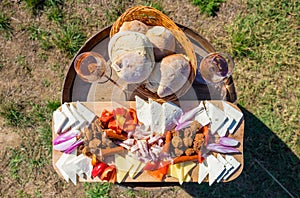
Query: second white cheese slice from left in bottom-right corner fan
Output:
[[206, 155, 226, 186]]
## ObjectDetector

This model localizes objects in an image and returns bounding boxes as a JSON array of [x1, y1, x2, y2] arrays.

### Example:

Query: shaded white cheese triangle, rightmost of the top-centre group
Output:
[[162, 102, 183, 131]]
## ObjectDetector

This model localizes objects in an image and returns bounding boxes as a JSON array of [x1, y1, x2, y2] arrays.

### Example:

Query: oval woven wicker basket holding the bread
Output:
[[110, 6, 197, 103]]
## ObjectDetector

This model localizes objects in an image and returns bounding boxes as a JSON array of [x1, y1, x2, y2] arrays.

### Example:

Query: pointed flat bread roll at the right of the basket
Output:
[[157, 54, 191, 98]]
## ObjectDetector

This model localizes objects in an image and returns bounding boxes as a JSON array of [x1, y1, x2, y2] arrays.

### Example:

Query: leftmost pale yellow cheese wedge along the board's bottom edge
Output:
[[115, 154, 133, 183]]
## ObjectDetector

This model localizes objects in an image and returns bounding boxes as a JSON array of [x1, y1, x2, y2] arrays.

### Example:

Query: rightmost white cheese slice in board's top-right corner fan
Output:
[[222, 101, 243, 134]]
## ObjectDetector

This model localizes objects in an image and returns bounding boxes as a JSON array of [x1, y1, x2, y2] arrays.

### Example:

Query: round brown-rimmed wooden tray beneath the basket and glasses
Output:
[[61, 24, 237, 103]]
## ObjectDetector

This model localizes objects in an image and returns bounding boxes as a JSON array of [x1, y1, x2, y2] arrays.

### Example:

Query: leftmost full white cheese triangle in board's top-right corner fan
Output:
[[206, 101, 227, 134]]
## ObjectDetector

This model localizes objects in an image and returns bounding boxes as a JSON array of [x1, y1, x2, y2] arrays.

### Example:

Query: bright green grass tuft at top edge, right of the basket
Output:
[[193, 0, 225, 16]]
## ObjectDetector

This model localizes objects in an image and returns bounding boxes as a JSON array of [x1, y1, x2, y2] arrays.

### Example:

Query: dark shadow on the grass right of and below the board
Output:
[[120, 106, 300, 198]]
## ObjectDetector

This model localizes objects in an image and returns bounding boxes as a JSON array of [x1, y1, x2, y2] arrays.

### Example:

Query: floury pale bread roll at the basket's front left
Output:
[[111, 51, 154, 84]]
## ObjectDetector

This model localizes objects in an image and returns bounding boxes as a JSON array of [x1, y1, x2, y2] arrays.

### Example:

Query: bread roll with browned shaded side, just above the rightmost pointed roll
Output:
[[146, 26, 176, 61]]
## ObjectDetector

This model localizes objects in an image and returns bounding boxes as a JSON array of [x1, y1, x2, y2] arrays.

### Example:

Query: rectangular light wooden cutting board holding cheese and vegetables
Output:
[[52, 101, 244, 182]]
